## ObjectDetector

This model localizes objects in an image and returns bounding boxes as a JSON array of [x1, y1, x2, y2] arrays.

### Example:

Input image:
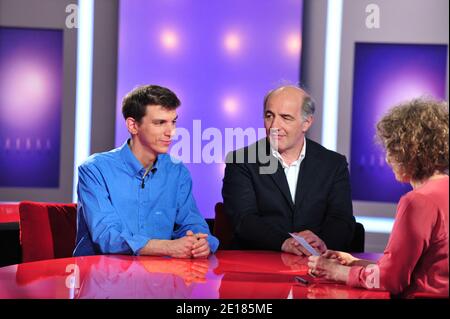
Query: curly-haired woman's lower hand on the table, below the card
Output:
[[308, 256, 350, 282]]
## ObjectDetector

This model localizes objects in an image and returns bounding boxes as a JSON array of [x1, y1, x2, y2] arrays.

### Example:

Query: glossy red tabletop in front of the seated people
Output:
[[0, 251, 389, 299]]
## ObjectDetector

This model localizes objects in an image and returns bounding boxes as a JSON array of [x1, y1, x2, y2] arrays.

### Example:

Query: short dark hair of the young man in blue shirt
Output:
[[122, 85, 181, 123]]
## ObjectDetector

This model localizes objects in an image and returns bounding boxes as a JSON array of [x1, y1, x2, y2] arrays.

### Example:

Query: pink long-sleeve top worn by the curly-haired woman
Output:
[[347, 176, 449, 298]]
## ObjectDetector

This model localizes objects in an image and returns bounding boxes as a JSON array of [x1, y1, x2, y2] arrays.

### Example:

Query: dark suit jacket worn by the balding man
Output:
[[222, 139, 355, 251]]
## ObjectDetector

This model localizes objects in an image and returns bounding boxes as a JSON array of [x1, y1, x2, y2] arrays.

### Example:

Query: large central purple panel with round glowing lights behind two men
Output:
[[115, 0, 302, 217]]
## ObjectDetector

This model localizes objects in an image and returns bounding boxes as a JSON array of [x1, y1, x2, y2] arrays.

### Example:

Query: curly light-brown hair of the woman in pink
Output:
[[377, 98, 449, 181]]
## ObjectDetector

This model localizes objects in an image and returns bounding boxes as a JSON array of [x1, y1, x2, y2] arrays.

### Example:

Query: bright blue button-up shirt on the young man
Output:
[[73, 143, 219, 256]]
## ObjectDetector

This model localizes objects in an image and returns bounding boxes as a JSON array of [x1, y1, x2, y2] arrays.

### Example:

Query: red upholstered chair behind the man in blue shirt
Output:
[[19, 201, 77, 262]]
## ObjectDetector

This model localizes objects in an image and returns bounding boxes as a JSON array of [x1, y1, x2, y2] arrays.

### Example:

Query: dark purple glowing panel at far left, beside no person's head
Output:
[[0, 27, 63, 188]]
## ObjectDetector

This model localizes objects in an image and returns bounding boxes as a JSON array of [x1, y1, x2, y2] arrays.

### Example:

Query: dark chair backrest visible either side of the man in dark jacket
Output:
[[212, 202, 365, 253]]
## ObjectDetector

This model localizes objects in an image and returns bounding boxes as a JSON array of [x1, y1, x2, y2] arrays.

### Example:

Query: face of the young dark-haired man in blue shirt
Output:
[[131, 105, 178, 155]]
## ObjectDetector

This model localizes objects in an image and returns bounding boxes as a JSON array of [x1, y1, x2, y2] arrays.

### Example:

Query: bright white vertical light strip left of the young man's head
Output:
[[72, 0, 94, 202]]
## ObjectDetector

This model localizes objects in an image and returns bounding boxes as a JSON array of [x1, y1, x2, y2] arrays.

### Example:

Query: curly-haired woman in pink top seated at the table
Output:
[[308, 99, 449, 298]]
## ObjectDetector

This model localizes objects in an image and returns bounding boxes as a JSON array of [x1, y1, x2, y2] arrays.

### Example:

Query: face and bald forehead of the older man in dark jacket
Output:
[[264, 87, 312, 154]]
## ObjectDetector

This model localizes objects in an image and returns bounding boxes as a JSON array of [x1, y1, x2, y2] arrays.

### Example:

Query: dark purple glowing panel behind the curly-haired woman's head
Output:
[[350, 43, 447, 203]]
